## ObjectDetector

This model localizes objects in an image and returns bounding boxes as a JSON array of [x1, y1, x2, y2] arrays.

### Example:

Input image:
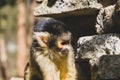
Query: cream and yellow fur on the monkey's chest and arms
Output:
[[26, 44, 77, 80]]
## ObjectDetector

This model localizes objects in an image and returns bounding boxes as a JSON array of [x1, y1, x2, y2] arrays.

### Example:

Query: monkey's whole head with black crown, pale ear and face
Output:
[[33, 19, 71, 56]]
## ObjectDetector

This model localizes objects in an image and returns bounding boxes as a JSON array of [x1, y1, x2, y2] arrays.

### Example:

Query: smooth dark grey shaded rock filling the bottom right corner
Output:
[[97, 55, 120, 80]]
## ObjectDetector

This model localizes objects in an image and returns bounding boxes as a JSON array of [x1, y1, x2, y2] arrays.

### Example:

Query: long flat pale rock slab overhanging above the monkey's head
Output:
[[34, 0, 102, 17]]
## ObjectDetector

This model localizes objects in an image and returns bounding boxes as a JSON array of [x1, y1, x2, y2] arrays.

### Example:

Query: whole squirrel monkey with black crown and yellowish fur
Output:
[[24, 19, 77, 80]]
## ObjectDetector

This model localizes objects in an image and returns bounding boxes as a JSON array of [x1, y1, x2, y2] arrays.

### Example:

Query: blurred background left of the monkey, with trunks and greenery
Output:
[[0, 0, 34, 80]]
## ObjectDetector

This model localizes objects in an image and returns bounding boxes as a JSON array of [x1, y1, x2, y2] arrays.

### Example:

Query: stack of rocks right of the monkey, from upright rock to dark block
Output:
[[77, 0, 120, 80]]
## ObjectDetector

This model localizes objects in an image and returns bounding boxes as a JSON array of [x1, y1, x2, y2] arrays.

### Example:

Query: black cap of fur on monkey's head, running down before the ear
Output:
[[33, 19, 69, 47]]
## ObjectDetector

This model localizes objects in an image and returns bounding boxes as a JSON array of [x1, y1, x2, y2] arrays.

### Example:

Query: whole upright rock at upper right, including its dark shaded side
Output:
[[95, 0, 120, 34]]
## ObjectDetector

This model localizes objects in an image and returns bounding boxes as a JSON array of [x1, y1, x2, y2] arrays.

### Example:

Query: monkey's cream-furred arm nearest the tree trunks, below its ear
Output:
[[35, 55, 60, 80]]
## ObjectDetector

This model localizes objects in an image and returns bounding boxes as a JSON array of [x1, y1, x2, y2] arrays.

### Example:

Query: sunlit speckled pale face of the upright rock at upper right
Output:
[[95, 5, 115, 34]]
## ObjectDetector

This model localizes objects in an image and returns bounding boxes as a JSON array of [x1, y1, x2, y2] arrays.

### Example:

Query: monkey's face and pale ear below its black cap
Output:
[[33, 32, 72, 57]]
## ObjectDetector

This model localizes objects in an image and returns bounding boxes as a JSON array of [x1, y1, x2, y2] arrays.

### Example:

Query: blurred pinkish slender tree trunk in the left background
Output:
[[17, 0, 27, 77]]
